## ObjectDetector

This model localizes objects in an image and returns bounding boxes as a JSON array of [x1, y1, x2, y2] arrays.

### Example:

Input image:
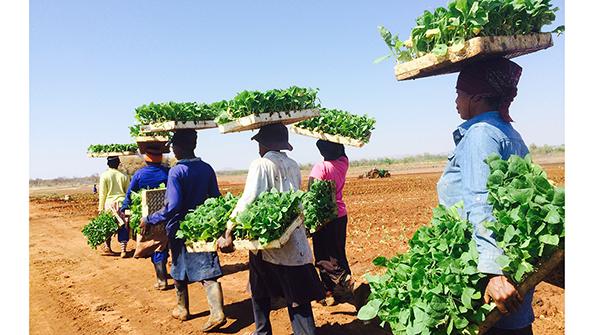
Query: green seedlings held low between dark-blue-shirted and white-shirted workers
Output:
[[176, 193, 239, 243]]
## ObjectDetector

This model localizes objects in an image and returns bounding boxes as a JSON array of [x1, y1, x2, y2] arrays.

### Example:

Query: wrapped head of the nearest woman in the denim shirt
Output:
[[455, 58, 523, 122]]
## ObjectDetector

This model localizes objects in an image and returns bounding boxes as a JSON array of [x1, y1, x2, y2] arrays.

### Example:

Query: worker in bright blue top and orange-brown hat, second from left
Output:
[[120, 145, 169, 290]]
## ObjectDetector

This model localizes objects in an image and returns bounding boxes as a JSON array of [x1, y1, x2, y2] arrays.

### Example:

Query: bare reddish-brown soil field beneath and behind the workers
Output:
[[29, 163, 564, 335]]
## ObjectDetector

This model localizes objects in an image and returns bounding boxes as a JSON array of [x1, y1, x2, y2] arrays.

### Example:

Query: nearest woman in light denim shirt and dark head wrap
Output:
[[437, 58, 534, 335]]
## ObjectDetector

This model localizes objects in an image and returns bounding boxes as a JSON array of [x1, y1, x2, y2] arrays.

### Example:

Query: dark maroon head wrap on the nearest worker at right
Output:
[[457, 58, 523, 122]]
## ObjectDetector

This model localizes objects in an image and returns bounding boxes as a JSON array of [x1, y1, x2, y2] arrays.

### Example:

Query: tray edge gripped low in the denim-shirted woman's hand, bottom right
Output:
[[479, 249, 564, 335]]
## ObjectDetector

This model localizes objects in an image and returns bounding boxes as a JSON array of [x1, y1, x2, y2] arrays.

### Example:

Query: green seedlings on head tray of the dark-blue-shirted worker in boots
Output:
[[135, 101, 220, 124]]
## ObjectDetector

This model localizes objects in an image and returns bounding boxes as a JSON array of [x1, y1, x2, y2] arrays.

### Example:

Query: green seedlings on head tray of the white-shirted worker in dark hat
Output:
[[215, 86, 320, 124]]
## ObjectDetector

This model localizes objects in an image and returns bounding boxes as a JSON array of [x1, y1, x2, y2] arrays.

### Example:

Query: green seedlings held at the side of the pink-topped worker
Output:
[[302, 179, 337, 233]]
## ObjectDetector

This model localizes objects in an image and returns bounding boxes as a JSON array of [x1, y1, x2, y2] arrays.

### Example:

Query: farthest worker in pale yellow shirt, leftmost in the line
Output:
[[98, 156, 129, 257]]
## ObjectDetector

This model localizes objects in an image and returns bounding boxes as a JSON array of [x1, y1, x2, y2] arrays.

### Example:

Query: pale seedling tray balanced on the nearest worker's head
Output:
[[395, 33, 554, 80]]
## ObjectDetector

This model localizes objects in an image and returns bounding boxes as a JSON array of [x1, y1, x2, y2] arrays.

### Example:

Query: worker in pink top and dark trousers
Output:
[[308, 140, 354, 305]]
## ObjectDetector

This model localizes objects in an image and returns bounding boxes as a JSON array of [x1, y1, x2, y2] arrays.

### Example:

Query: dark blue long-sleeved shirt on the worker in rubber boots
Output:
[[146, 158, 221, 240]]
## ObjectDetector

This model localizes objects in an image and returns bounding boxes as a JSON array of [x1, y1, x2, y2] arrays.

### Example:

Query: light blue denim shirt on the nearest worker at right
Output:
[[437, 112, 534, 329]]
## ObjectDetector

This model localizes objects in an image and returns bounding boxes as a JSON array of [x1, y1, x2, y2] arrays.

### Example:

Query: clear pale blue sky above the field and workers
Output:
[[29, 0, 564, 178]]
